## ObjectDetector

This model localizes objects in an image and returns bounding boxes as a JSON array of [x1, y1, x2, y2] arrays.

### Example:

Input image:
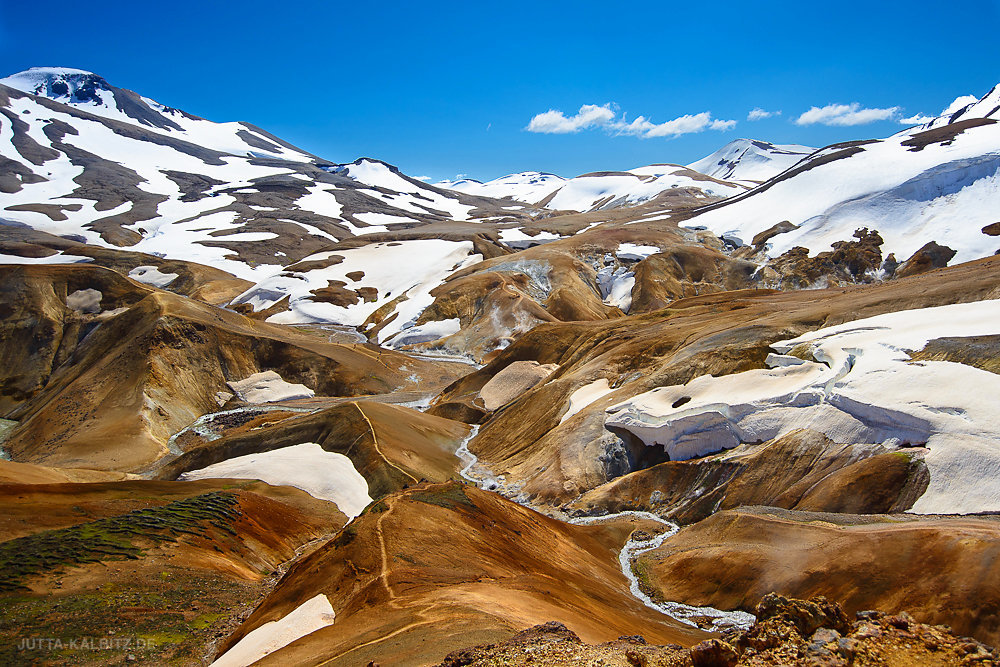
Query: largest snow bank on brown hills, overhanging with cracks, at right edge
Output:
[[605, 300, 1000, 513]]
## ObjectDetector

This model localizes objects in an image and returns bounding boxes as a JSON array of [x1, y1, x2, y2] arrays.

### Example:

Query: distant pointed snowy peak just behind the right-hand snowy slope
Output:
[[688, 139, 816, 183]]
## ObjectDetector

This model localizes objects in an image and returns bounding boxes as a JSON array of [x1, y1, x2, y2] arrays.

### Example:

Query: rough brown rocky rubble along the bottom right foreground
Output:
[[436, 593, 1000, 667]]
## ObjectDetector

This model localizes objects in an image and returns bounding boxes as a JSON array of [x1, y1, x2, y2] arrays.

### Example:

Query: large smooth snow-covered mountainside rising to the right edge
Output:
[[685, 88, 1000, 262]]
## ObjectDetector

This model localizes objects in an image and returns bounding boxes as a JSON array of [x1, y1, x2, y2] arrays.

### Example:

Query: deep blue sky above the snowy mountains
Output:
[[0, 0, 1000, 180]]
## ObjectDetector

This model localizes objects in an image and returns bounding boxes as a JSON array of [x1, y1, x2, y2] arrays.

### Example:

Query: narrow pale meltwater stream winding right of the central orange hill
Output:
[[455, 426, 756, 631]]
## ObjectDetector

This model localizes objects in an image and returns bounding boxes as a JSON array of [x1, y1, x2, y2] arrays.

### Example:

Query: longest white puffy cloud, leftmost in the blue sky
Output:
[[525, 103, 736, 139]]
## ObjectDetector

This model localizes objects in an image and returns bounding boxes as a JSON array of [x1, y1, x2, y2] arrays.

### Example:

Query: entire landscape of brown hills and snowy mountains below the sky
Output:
[[0, 68, 1000, 665]]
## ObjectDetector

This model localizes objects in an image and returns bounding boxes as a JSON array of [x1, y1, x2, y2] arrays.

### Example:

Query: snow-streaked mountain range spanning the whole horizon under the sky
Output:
[[0, 68, 1000, 308]]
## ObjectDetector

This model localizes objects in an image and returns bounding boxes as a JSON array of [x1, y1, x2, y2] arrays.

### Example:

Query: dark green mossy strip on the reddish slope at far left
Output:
[[0, 491, 241, 591]]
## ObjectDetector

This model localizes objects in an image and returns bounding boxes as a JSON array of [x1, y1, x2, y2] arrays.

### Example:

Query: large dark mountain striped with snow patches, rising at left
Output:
[[0, 68, 532, 280]]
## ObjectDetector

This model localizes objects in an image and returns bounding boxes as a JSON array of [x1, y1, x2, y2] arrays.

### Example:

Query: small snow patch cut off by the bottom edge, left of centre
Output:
[[212, 593, 336, 667]]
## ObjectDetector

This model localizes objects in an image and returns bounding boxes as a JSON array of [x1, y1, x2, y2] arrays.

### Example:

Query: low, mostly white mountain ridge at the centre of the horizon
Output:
[[437, 164, 746, 212]]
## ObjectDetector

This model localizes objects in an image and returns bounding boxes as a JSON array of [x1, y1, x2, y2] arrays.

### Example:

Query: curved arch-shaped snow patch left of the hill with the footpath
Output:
[[180, 442, 372, 519]]
